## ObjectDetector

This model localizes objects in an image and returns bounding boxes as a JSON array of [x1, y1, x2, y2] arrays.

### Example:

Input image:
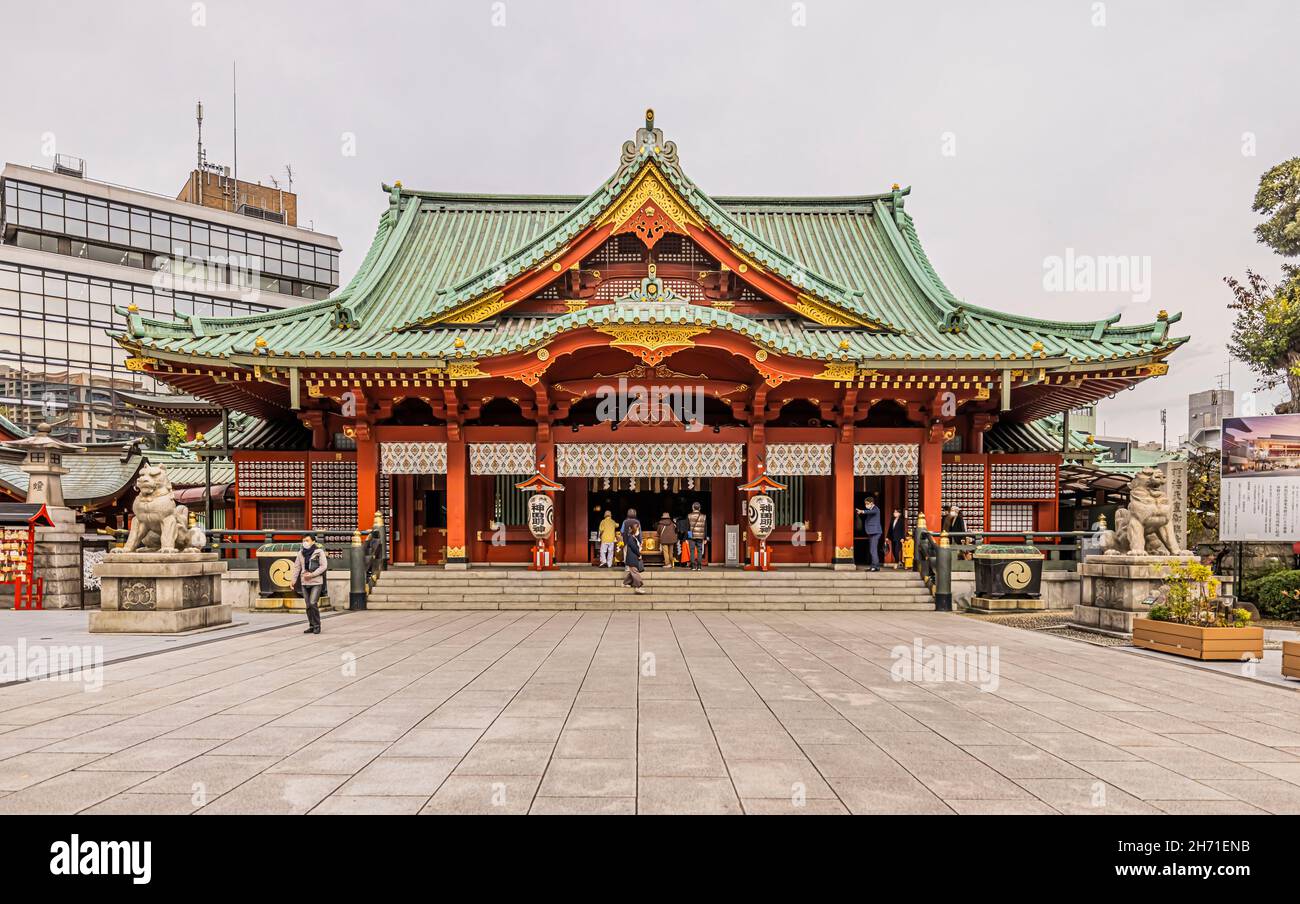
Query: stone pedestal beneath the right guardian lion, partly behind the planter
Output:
[[1074, 553, 1197, 633]]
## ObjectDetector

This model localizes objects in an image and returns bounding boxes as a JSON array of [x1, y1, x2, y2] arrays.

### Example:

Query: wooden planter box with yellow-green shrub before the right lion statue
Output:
[[1134, 562, 1264, 659]]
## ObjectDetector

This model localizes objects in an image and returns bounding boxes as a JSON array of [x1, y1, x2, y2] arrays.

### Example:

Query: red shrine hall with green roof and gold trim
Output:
[[117, 112, 1186, 566]]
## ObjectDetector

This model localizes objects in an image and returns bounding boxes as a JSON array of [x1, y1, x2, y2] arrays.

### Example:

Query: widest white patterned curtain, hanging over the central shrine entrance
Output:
[[555, 442, 745, 477]]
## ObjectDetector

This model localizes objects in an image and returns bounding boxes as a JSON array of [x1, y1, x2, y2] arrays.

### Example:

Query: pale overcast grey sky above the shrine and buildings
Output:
[[0, 0, 1300, 444]]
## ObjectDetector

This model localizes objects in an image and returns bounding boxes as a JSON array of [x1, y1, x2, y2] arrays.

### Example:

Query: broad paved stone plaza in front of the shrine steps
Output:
[[0, 611, 1300, 814]]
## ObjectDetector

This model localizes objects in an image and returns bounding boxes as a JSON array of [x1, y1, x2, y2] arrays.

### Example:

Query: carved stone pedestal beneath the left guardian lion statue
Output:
[[90, 553, 231, 633]]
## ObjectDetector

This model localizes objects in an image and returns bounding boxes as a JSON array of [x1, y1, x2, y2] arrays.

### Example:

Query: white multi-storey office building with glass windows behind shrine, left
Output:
[[0, 164, 339, 442]]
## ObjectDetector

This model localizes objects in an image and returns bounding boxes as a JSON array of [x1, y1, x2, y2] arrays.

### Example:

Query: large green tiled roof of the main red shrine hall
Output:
[[121, 113, 1186, 382]]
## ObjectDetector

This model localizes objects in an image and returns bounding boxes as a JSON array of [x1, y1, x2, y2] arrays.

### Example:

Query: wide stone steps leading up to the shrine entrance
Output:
[[367, 566, 935, 611]]
